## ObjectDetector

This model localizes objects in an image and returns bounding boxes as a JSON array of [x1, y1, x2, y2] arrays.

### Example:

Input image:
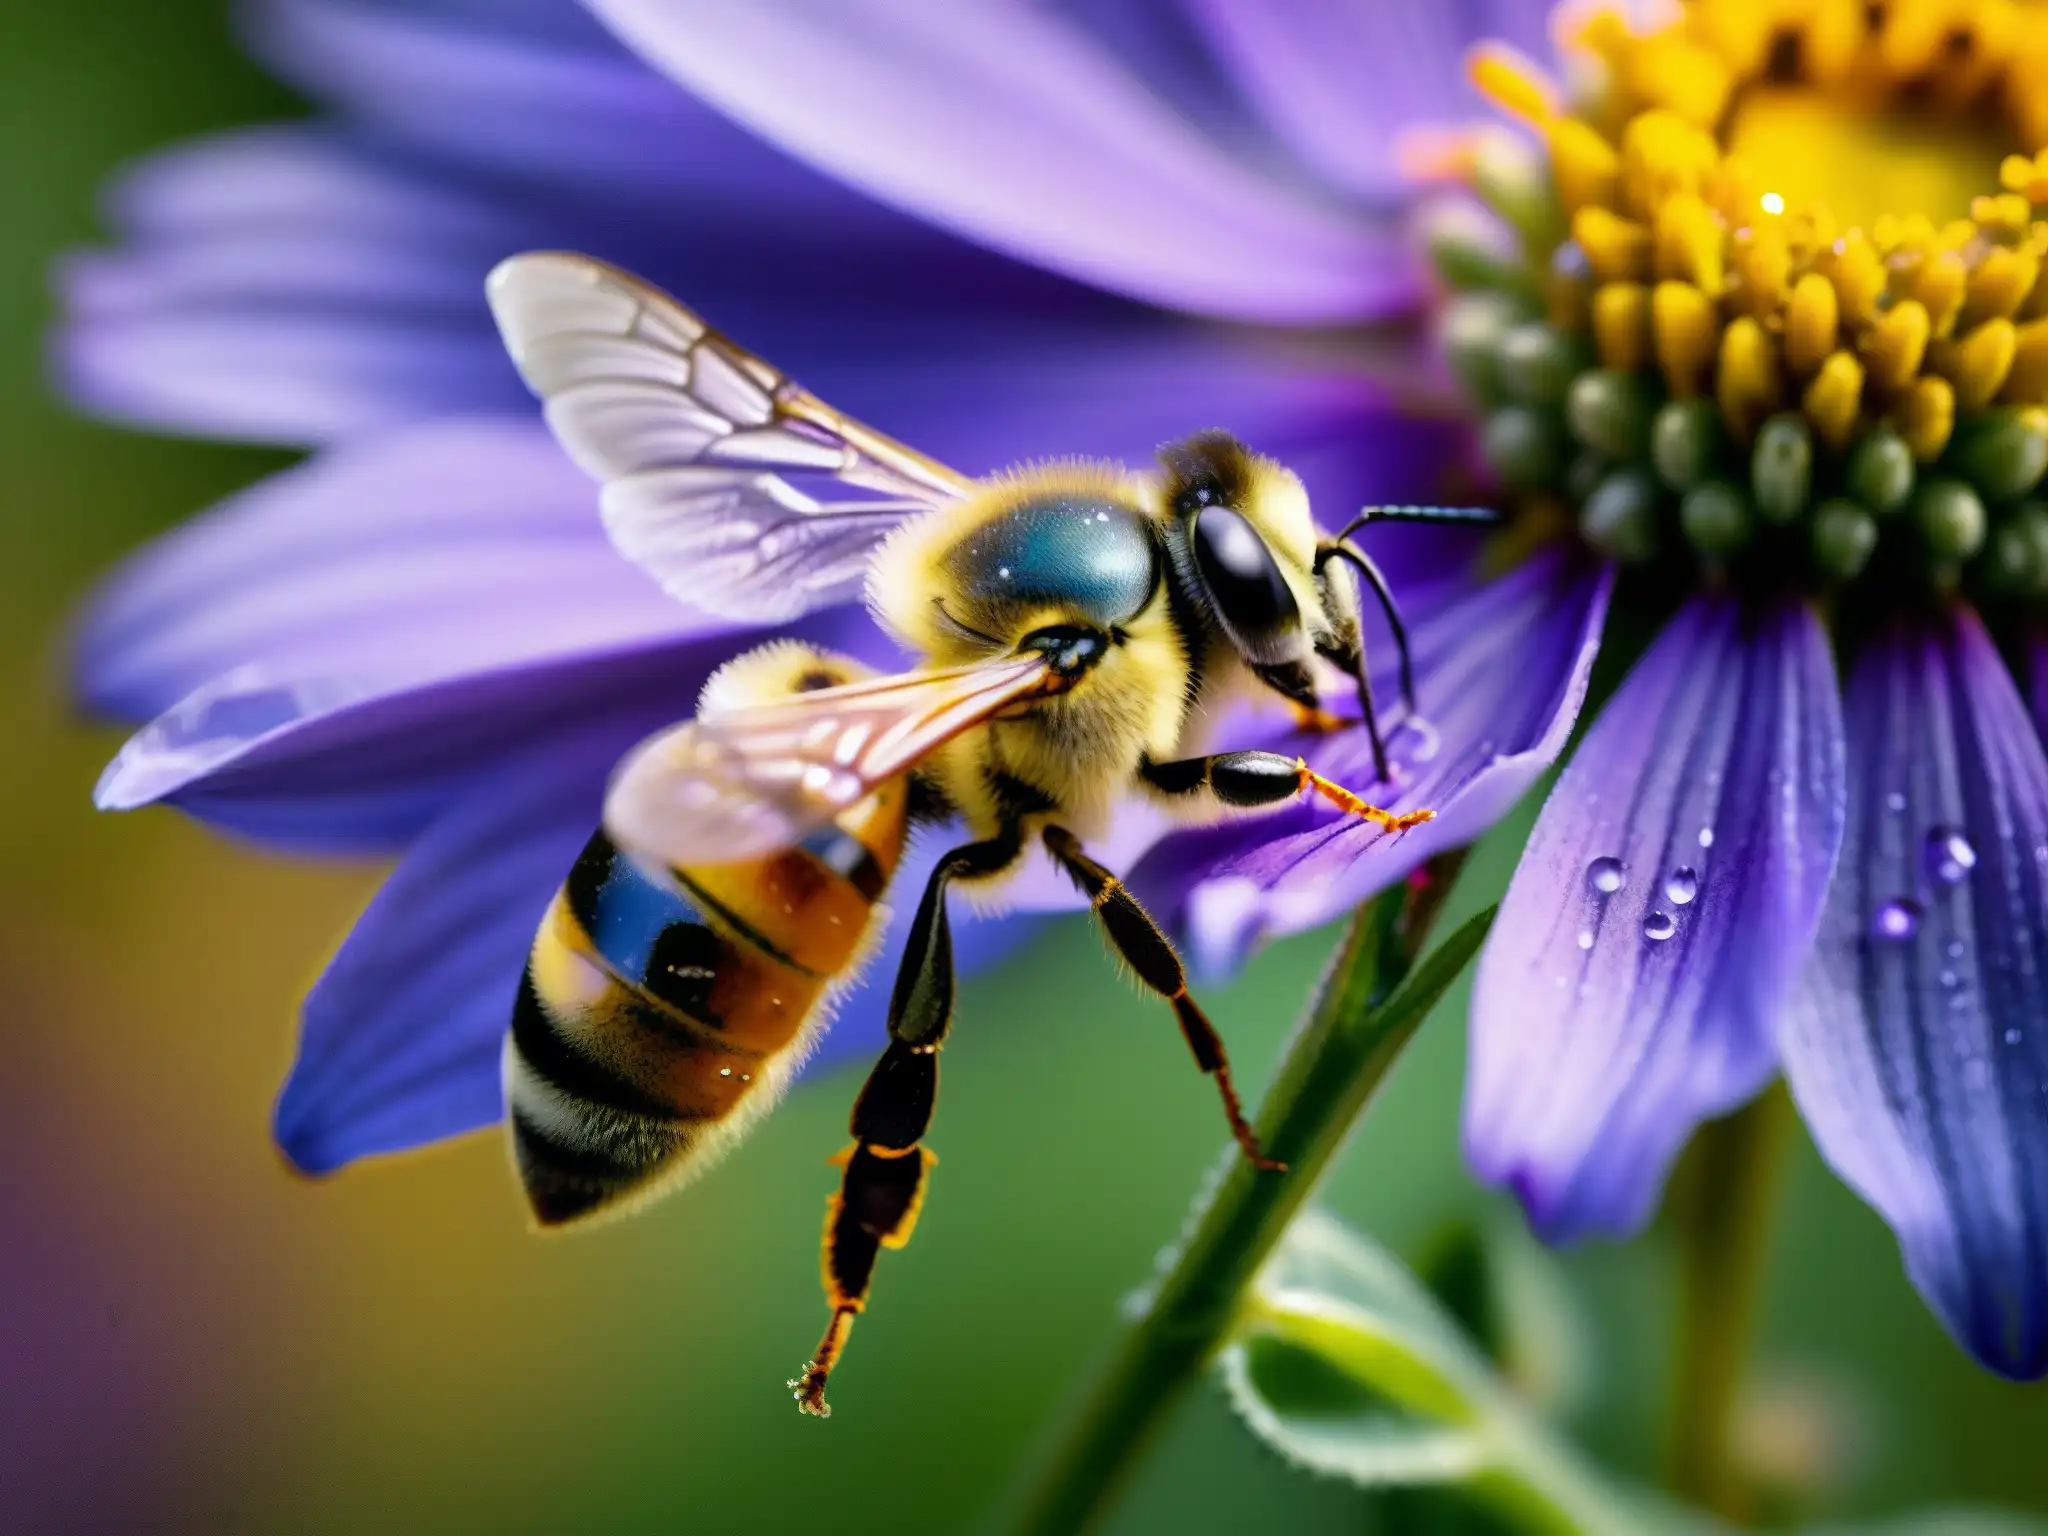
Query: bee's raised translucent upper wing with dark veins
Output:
[[485, 252, 969, 623]]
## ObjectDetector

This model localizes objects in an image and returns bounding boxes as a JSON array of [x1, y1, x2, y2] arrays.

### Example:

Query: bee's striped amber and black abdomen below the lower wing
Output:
[[506, 806, 903, 1227]]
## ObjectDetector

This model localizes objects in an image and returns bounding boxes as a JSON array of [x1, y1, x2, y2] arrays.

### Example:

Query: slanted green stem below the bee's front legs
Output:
[[1010, 868, 1493, 1536]]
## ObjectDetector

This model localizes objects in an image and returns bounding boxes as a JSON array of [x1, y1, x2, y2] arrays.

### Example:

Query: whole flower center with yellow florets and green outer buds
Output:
[[1407, 0, 2048, 602]]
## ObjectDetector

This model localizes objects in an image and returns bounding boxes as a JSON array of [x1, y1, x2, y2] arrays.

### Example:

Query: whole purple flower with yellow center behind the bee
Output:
[[61, 0, 2048, 1376]]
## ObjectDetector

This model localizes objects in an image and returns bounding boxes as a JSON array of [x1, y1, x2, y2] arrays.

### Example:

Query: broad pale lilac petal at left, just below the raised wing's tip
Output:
[[74, 420, 696, 719]]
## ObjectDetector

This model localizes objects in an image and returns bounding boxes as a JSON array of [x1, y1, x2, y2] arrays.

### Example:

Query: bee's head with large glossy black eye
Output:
[[1159, 432, 1329, 707]]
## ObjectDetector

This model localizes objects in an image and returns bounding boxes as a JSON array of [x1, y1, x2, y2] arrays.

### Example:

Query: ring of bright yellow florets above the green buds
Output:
[[1473, 0, 2048, 461]]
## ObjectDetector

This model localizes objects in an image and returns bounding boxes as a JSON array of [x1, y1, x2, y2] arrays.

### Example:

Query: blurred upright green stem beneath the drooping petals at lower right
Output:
[[1667, 1085, 1792, 1522]]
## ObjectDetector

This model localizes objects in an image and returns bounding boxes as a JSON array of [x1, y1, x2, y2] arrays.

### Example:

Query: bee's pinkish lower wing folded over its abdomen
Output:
[[604, 653, 1061, 864]]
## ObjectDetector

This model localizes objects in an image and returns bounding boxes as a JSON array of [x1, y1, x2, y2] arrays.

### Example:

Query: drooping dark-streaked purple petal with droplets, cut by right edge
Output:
[[1780, 612, 2048, 1378]]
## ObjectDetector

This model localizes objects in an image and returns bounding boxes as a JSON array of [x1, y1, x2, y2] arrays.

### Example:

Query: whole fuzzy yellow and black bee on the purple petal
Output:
[[487, 252, 1474, 1415]]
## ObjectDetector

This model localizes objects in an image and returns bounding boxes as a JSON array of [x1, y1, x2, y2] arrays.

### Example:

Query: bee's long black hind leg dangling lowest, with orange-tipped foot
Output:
[[788, 827, 1024, 1417]]
